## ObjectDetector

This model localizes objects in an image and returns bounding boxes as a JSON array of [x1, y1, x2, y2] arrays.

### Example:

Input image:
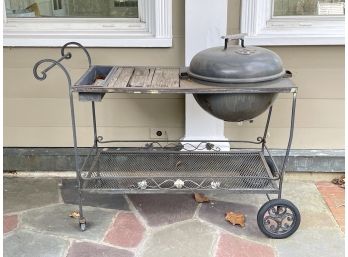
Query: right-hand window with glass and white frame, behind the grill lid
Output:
[[241, 0, 345, 45]]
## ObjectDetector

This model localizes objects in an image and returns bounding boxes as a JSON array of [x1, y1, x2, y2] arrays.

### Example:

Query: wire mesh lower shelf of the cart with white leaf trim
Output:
[[81, 148, 279, 193]]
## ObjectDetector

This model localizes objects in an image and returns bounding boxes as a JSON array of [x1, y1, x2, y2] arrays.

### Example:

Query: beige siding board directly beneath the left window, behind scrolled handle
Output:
[[4, 35, 185, 69]]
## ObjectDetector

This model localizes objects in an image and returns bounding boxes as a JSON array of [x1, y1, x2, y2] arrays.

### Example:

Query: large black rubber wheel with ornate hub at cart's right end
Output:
[[257, 199, 301, 239]]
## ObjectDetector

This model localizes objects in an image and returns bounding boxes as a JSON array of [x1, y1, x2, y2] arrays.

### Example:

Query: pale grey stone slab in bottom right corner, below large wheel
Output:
[[271, 228, 344, 257]]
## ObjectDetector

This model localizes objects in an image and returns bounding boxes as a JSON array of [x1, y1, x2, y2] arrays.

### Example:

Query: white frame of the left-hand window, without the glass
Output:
[[3, 0, 172, 47]]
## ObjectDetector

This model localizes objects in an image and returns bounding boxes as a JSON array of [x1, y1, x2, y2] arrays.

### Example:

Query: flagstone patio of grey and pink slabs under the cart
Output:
[[4, 177, 344, 257]]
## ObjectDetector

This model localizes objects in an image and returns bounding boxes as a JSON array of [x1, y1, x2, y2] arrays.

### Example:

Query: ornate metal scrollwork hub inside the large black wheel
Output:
[[263, 206, 295, 234]]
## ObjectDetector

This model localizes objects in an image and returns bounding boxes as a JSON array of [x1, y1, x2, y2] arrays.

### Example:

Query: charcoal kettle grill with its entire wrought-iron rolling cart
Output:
[[33, 35, 300, 238]]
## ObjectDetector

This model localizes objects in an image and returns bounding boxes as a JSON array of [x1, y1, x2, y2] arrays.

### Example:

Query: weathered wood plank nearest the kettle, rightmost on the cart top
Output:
[[150, 68, 180, 88]]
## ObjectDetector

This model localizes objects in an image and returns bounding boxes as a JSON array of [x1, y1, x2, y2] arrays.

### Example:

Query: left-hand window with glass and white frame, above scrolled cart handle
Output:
[[4, 0, 172, 47]]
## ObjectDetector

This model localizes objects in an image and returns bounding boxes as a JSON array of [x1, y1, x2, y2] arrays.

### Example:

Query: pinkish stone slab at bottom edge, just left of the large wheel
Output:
[[215, 233, 276, 257]]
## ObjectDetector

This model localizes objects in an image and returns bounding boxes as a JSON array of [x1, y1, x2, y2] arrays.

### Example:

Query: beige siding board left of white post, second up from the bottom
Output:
[[4, 98, 184, 127]]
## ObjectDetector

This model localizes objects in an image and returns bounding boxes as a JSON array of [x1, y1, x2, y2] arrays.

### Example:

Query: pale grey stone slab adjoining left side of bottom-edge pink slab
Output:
[[141, 221, 217, 257]]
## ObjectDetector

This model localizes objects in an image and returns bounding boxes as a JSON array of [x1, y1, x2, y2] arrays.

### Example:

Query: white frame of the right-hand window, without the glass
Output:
[[241, 0, 344, 45]]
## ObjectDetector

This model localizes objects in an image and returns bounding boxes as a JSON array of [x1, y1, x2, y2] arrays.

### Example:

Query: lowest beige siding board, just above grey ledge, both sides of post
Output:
[[4, 126, 344, 149]]
